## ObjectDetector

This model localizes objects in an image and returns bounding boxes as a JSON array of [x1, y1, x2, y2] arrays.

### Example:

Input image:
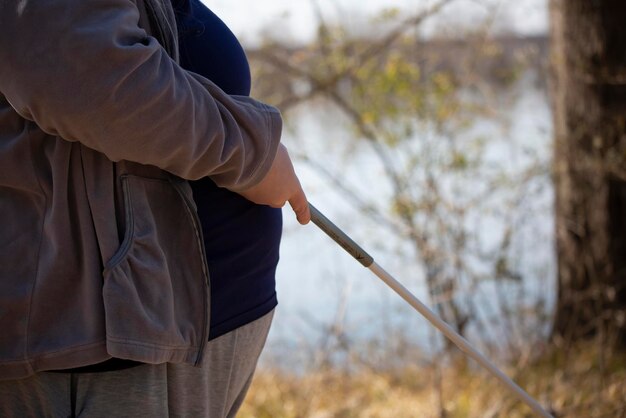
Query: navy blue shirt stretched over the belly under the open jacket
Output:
[[172, 0, 282, 339]]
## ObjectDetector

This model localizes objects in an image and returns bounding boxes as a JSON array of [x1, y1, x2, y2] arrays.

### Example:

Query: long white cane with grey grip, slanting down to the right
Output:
[[309, 203, 553, 418]]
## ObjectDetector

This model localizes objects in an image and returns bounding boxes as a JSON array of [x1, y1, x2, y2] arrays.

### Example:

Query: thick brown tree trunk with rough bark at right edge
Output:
[[550, 0, 626, 347]]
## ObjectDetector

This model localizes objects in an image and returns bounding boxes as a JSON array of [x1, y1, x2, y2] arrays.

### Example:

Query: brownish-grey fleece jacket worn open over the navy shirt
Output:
[[0, 0, 281, 379]]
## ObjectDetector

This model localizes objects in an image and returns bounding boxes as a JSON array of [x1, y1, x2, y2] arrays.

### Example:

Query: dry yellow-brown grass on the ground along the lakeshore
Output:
[[238, 346, 626, 418]]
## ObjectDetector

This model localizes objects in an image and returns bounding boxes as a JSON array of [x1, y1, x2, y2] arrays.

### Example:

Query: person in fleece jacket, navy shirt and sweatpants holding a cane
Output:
[[0, 0, 310, 417]]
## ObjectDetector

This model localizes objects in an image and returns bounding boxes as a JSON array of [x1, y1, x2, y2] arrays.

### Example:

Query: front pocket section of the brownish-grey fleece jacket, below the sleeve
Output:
[[103, 175, 209, 362]]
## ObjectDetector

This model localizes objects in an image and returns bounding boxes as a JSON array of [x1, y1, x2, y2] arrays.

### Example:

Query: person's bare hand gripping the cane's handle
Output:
[[237, 144, 311, 225]]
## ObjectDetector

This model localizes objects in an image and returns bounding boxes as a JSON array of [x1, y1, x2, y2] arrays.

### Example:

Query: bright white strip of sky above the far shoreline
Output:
[[202, 0, 548, 45]]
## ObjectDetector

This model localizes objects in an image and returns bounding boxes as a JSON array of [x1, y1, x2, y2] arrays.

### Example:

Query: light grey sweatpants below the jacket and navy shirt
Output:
[[0, 312, 273, 418]]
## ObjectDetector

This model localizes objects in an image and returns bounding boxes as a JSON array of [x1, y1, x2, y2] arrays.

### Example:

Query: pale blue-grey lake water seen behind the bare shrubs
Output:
[[262, 72, 555, 365]]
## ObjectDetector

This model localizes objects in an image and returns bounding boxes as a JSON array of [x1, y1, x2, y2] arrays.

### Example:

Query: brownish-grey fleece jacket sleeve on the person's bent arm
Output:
[[0, 0, 282, 190]]
